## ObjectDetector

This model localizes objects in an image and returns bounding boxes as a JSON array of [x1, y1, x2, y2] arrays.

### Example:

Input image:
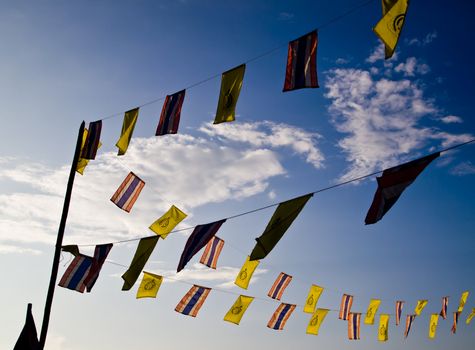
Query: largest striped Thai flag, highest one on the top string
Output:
[[283, 30, 318, 92]]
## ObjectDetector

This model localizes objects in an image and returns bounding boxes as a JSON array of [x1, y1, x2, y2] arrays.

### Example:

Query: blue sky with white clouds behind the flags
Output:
[[0, 0, 475, 350]]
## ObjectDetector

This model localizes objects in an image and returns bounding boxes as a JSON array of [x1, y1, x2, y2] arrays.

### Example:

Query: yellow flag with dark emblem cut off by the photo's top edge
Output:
[[373, 0, 409, 59]]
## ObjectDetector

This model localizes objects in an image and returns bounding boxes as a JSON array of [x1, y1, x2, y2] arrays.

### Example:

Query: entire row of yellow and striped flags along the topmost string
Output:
[[77, 0, 409, 174]]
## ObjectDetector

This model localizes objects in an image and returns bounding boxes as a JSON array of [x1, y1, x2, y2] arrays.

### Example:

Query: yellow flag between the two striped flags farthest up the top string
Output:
[[213, 64, 246, 124]]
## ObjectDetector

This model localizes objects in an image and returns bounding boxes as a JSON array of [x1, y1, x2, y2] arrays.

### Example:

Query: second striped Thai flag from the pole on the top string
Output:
[[155, 90, 185, 136]]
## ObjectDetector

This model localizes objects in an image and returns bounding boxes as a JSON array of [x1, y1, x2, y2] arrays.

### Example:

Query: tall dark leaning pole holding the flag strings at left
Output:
[[40, 122, 85, 350]]
